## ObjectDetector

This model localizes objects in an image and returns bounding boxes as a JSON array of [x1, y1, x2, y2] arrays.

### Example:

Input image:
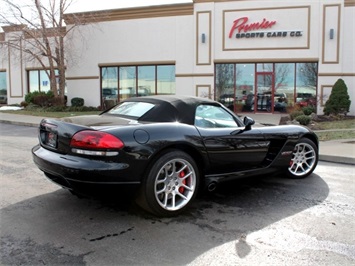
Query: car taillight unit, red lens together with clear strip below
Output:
[[70, 130, 124, 156]]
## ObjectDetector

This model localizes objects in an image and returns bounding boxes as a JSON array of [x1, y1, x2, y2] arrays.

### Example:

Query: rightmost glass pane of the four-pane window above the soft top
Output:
[[157, 65, 175, 94]]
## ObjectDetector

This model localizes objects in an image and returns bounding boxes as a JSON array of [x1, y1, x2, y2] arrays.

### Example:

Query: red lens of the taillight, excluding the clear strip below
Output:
[[70, 130, 124, 149]]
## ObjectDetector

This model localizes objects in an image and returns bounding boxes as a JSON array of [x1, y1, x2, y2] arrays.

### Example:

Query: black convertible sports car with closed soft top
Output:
[[32, 96, 318, 216]]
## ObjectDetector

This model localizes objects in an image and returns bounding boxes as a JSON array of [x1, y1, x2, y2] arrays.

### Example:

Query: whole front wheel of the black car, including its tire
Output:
[[287, 138, 318, 178]]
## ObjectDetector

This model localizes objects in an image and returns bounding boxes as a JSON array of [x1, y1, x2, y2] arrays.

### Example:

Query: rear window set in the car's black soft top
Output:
[[107, 102, 154, 118]]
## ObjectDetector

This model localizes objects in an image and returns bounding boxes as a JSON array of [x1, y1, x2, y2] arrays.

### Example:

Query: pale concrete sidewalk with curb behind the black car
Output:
[[0, 112, 355, 165]]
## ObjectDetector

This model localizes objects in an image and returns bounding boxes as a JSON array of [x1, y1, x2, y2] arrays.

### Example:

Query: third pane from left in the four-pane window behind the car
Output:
[[138, 66, 155, 96]]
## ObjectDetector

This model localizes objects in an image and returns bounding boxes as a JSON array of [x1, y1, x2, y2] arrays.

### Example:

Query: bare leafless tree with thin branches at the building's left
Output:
[[0, 0, 74, 104]]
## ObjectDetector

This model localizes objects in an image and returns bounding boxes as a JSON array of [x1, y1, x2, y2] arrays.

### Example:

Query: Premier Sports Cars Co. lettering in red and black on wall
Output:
[[229, 17, 302, 39]]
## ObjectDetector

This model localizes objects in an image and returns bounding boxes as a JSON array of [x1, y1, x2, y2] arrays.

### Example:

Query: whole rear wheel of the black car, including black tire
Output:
[[137, 150, 199, 217]]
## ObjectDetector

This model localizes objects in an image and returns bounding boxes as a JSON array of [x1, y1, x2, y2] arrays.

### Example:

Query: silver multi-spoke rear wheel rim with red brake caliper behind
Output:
[[154, 158, 196, 211]]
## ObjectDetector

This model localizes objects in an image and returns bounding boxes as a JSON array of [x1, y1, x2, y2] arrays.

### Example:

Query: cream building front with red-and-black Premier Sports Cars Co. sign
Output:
[[0, 0, 355, 115]]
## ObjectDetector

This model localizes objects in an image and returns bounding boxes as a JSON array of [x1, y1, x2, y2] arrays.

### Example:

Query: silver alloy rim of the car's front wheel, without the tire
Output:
[[288, 142, 317, 177]]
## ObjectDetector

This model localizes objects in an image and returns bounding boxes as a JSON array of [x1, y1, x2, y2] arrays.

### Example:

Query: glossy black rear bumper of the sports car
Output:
[[32, 145, 140, 188]]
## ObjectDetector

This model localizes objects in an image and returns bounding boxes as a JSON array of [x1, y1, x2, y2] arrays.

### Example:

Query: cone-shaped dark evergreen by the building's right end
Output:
[[323, 79, 351, 115]]
